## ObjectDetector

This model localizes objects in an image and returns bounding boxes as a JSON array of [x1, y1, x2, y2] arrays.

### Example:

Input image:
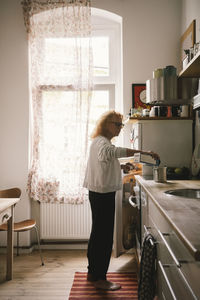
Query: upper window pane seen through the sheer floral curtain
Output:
[[42, 38, 92, 86]]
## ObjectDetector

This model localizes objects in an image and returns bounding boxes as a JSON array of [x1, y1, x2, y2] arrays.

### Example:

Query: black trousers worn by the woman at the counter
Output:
[[87, 191, 115, 280]]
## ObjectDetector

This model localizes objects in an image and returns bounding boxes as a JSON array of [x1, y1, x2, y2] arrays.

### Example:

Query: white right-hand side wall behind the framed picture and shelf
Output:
[[181, 0, 200, 145]]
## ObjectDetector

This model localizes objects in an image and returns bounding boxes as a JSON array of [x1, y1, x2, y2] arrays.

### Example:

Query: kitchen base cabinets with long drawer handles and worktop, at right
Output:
[[136, 176, 200, 300]]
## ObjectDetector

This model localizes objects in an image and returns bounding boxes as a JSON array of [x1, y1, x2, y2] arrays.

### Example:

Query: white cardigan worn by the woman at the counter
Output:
[[83, 136, 127, 193]]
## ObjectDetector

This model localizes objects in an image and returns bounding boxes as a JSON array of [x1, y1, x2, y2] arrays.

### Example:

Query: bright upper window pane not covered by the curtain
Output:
[[92, 36, 109, 76]]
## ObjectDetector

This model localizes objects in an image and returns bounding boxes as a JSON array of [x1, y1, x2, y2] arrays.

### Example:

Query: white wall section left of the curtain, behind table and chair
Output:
[[0, 0, 30, 245]]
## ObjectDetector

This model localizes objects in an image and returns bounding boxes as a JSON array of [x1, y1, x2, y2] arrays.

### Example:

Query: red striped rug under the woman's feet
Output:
[[69, 272, 138, 300]]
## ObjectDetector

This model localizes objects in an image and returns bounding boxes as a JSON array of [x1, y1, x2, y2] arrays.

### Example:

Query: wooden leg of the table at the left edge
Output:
[[6, 207, 14, 280]]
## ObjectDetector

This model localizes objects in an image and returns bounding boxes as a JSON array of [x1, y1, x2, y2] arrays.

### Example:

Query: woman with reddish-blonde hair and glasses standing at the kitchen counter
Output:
[[83, 111, 159, 290]]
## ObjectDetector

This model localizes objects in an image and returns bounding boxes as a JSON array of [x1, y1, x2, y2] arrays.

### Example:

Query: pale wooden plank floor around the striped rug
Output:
[[0, 250, 137, 300]]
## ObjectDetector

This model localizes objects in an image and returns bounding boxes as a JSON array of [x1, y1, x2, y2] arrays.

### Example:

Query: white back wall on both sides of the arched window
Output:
[[0, 0, 187, 245]]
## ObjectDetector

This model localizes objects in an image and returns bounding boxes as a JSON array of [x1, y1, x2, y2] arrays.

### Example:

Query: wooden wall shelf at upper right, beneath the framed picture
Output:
[[179, 51, 200, 78]]
